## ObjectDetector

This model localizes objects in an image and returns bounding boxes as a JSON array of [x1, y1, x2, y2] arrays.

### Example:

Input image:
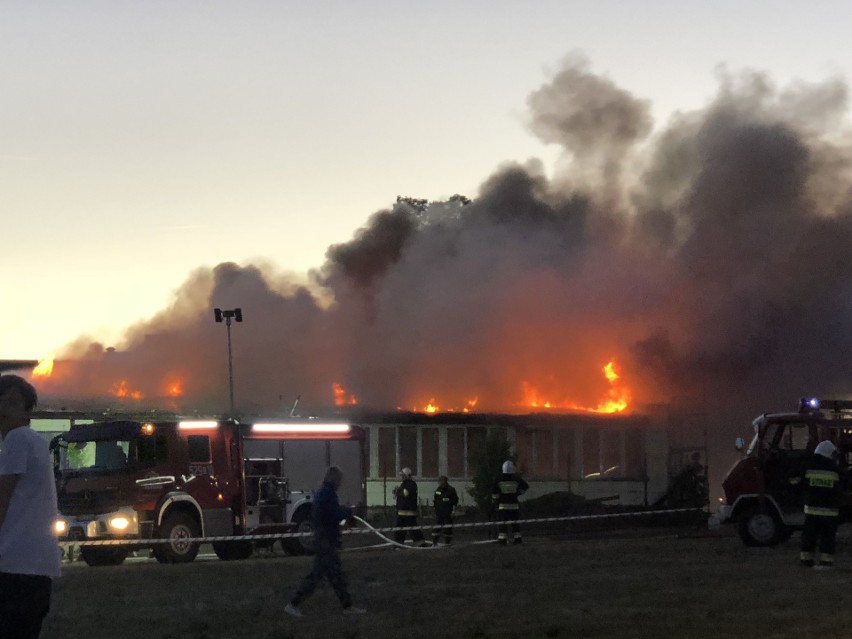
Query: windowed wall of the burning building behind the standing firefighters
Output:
[[363, 416, 668, 507]]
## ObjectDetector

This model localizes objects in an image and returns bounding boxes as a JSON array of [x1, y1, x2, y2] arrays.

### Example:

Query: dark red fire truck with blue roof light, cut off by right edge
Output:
[[719, 398, 852, 546]]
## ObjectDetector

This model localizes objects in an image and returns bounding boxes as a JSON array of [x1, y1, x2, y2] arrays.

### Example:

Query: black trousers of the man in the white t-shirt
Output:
[[0, 572, 53, 639]]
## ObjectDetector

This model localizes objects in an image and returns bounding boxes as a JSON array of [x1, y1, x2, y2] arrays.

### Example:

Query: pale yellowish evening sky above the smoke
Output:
[[0, 0, 852, 359]]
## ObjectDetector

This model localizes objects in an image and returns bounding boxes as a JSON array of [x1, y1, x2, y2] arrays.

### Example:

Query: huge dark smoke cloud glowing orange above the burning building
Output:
[[38, 58, 852, 436]]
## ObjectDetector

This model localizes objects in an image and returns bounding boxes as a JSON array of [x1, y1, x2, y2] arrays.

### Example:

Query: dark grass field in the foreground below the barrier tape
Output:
[[42, 528, 852, 639]]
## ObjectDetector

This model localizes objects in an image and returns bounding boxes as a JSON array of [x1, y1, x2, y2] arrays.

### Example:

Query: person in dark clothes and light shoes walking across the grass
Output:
[[284, 466, 367, 617]]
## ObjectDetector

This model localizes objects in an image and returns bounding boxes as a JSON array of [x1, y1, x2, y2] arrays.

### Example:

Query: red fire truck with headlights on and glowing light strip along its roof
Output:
[[51, 419, 366, 566]]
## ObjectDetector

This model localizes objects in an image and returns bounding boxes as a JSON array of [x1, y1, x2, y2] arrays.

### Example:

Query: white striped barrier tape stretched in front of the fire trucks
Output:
[[59, 508, 702, 550]]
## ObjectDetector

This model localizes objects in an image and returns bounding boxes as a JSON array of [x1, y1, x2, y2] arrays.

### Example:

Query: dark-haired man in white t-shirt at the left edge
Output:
[[0, 375, 60, 639]]
